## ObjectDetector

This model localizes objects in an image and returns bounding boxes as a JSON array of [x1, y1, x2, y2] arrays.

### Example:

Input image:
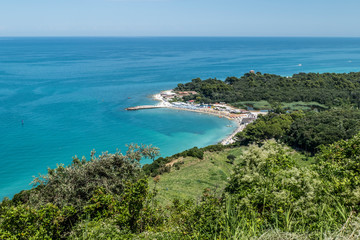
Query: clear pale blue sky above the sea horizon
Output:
[[0, 0, 360, 37]]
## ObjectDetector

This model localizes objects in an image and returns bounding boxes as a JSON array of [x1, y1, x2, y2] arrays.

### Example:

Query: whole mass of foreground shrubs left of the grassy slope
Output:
[[0, 145, 158, 239]]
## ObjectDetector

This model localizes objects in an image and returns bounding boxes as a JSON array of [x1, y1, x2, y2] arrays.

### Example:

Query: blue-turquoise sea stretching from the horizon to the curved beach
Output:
[[0, 38, 360, 198]]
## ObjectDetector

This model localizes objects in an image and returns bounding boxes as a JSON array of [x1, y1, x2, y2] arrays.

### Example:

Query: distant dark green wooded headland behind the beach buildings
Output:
[[175, 72, 360, 108]]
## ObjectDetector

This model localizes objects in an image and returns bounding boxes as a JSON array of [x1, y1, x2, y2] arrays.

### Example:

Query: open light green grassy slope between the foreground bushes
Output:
[[149, 148, 244, 204]]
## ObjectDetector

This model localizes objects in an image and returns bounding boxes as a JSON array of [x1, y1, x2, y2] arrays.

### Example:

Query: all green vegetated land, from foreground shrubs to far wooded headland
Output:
[[0, 73, 360, 239]]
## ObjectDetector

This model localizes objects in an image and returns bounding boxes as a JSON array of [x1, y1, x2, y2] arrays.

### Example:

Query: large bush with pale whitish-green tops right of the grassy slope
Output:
[[226, 141, 349, 232]]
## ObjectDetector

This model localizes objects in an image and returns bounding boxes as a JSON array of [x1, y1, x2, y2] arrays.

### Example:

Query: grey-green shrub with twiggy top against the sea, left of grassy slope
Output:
[[29, 145, 158, 210]]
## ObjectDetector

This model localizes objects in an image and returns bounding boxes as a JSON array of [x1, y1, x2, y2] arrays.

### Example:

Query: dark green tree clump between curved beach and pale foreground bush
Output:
[[237, 109, 360, 153]]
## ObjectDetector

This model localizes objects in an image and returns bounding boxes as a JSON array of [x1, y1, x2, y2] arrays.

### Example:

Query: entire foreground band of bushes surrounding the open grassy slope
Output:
[[0, 135, 360, 239]]
